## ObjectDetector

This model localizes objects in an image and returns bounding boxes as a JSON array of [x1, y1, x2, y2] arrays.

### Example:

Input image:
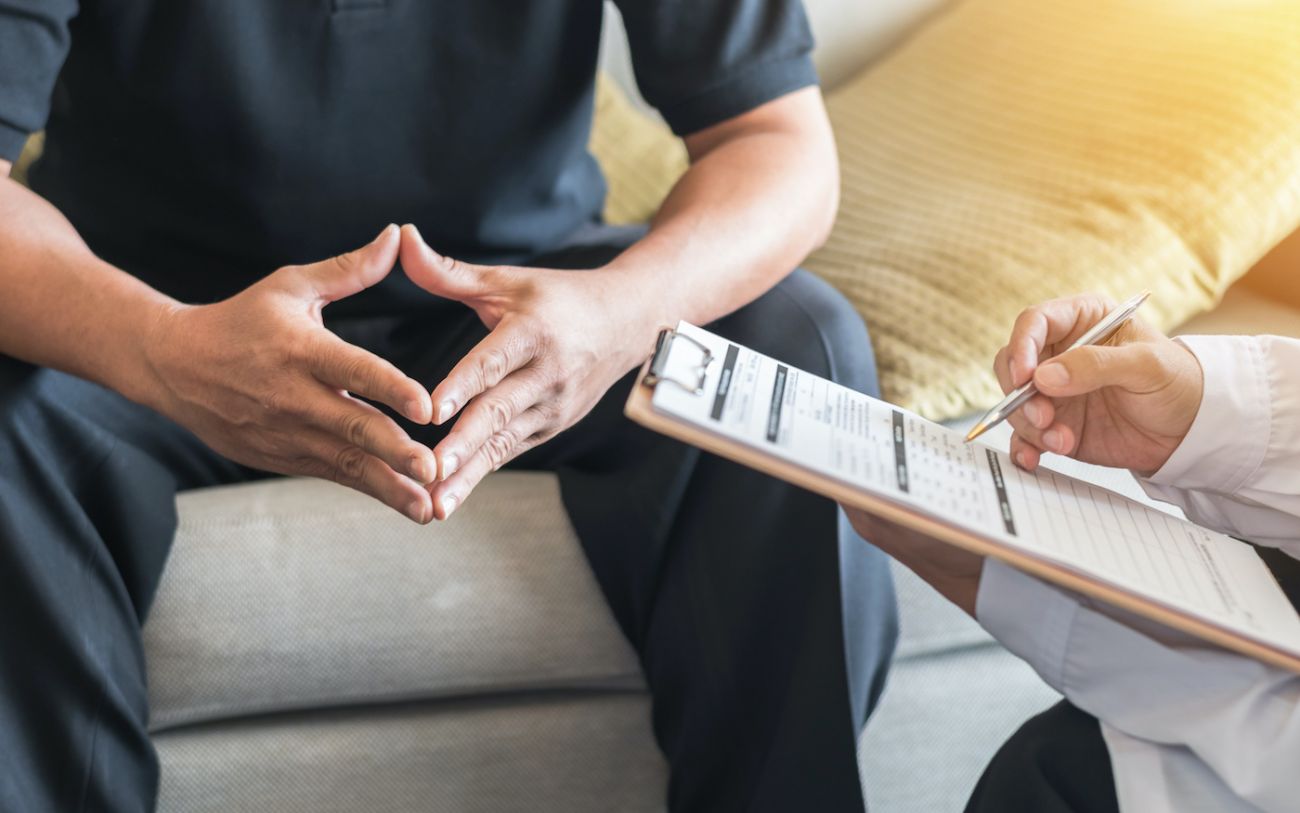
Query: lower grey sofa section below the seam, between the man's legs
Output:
[[155, 692, 667, 813]]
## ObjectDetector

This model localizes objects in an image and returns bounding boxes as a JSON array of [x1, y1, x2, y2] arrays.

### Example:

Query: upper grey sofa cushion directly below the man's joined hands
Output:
[[144, 472, 642, 730]]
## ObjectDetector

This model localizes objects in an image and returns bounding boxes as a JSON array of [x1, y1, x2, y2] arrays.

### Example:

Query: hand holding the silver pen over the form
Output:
[[993, 294, 1203, 475]]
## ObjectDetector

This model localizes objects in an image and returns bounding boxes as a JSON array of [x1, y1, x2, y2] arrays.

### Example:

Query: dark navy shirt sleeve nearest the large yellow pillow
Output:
[[605, 0, 818, 135]]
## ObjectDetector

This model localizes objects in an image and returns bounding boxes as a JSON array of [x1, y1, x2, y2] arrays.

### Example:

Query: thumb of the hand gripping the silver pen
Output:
[[1034, 342, 1166, 398]]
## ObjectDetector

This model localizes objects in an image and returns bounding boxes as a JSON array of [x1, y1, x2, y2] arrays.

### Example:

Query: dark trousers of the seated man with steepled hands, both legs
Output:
[[0, 228, 896, 813]]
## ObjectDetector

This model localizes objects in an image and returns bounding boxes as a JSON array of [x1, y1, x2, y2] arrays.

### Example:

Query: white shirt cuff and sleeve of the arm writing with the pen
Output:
[[1139, 336, 1300, 558]]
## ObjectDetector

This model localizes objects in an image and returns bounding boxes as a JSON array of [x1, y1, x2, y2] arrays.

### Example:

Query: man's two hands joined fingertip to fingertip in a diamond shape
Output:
[[135, 225, 653, 523]]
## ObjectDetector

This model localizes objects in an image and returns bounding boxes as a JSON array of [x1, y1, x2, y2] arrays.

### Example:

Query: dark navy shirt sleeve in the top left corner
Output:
[[0, 0, 78, 161]]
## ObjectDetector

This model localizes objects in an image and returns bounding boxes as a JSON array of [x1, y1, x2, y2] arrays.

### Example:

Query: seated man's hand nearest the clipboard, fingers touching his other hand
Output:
[[402, 225, 655, 519]]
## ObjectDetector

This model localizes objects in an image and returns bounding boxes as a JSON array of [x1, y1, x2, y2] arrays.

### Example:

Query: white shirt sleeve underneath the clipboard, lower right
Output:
[[976, 559, 1300, 812]]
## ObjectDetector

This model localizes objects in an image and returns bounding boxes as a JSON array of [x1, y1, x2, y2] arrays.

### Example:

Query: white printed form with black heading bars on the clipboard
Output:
[[651, 323, 1300, 652]]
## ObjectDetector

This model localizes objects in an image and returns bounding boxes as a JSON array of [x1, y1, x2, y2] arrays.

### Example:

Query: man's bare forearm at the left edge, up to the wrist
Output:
[[0, 167, 176, 399]]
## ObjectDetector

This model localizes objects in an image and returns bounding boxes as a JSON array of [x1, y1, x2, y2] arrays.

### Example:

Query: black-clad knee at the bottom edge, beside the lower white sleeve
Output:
[[966, 701, 1119, 813]]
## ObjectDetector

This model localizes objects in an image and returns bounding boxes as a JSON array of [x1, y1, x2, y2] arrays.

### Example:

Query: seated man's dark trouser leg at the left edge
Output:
[[0, 356, 250, 812]]
